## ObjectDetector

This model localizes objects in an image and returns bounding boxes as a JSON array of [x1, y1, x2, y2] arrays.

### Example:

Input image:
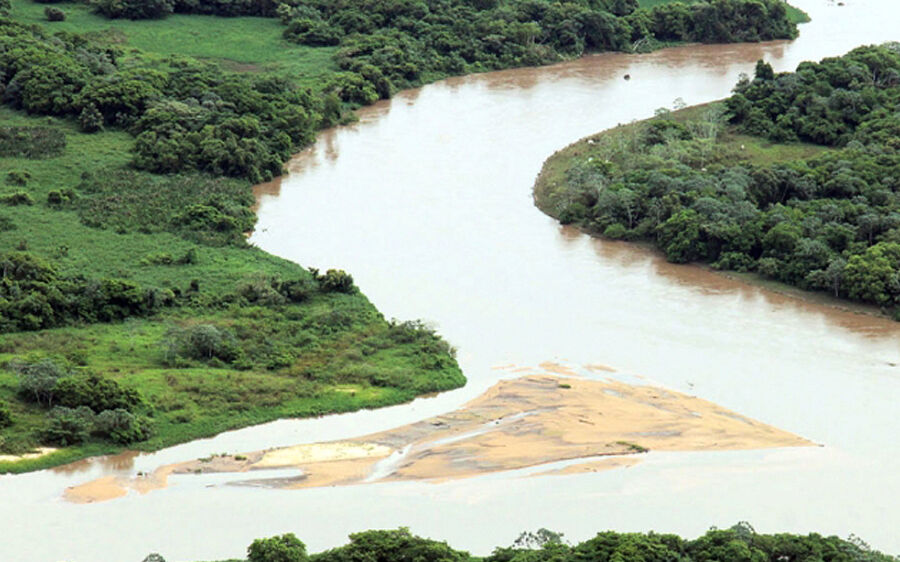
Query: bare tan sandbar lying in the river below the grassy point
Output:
[[65, 365, 812, 502]]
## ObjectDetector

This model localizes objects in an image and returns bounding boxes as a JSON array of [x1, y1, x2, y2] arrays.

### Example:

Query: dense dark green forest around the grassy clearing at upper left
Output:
[[0, 0, 797, 182]]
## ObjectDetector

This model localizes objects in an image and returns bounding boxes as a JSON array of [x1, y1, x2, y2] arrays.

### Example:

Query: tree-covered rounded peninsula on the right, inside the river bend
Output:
[[536, 44, 900, 316]]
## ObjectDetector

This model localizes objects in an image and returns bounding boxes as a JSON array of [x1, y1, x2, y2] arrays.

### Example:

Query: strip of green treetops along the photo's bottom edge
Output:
[[144, 522, 897, 562]]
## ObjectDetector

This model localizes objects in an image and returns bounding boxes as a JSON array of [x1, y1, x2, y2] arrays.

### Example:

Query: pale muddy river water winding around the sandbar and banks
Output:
[[0, 0, 900, 562]]
